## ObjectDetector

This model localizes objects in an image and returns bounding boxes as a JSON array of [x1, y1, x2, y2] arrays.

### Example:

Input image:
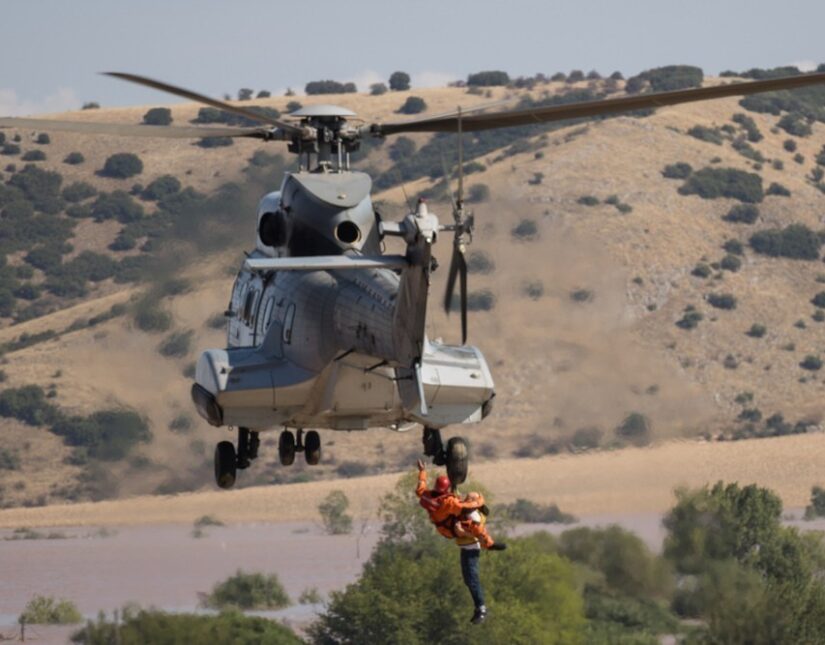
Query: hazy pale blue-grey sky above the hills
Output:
[[0, 0, 825, 116]]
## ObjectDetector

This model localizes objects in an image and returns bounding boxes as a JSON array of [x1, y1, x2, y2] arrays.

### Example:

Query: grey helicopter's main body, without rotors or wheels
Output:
[[193, 173, 493, 431]]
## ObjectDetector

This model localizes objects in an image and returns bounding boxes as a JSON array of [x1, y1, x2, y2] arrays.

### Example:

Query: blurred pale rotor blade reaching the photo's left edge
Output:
[[0, 117, 267, 139]]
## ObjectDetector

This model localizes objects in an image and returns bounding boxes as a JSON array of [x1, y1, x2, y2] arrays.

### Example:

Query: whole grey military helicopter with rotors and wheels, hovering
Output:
[[0, 72, 825, 488]]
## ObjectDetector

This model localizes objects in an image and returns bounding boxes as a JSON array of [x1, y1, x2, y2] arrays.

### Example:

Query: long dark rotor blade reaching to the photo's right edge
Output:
[[369, 72, 825, 135]]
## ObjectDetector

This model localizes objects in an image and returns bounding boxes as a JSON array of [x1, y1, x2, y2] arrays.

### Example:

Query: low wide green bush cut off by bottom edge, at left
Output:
[[67, 608, 304, 645]]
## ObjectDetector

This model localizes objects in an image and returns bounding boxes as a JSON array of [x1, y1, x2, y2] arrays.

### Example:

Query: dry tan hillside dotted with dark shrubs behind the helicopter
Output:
[[0, 68, 825, 505]]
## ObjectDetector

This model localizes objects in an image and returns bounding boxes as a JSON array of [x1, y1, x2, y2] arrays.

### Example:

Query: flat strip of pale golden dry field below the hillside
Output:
[[0, 434, 825, 528]]
